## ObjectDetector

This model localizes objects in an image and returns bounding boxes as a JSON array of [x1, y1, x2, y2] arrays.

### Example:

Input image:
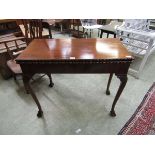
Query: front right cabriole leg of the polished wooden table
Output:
[[110, 74, 128, 117]]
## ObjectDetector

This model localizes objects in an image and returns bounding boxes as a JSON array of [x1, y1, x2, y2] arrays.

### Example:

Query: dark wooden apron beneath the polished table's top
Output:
[[21, 62, 130, 74]]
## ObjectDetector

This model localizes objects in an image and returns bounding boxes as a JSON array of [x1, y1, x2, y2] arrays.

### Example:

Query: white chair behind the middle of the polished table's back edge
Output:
[[80, 19, 102, 38]]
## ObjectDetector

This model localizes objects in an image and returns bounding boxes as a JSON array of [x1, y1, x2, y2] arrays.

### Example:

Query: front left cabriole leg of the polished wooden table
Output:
[[23, 75, 43, 117]]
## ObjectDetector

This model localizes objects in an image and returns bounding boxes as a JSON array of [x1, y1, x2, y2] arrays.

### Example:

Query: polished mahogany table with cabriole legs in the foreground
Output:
[[16, 38, 133, 117]]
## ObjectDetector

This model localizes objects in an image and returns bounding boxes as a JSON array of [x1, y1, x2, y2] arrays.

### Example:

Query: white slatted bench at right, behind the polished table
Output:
[[116, 19, 155, 78]]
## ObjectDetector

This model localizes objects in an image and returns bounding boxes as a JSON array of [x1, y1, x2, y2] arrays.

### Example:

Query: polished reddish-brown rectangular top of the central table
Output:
[[16, 38, 133, 62]]
